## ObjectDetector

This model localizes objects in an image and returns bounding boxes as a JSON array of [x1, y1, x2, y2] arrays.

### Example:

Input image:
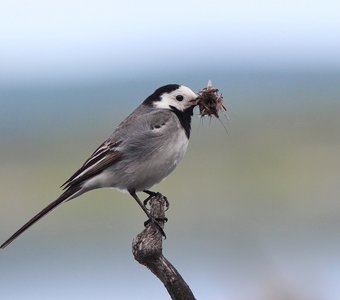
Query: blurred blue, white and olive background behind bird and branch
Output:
[[0, 0, 340, 300]]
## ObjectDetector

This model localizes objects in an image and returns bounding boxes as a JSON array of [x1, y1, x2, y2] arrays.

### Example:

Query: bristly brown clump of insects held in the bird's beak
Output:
[[197, 80, 227, 118]]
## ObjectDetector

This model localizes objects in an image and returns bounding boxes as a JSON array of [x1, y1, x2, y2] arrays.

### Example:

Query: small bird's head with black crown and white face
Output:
[[143, 84, 198, 111]]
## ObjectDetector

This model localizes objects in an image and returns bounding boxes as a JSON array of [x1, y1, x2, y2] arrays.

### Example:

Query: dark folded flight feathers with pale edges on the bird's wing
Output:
[[61, 139, 122, 189]]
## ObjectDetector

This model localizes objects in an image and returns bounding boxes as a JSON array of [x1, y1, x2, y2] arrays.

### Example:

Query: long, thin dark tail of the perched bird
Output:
[[0, 186, 81, 249]]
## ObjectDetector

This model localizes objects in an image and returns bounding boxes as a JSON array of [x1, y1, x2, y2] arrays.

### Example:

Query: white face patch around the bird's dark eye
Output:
[[154, 85, 198, 111]]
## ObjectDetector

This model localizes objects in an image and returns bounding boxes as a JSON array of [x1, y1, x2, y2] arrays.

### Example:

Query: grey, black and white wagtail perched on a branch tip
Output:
[[0, 84, 198, 249]]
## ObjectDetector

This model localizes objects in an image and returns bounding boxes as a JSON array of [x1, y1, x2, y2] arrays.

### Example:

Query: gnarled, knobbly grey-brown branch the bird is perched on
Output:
[[132, 194, 195, 300]]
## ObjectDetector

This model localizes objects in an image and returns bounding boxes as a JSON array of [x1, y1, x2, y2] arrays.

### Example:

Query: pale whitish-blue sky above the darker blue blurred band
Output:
[[0, 0, 340, 81]]
